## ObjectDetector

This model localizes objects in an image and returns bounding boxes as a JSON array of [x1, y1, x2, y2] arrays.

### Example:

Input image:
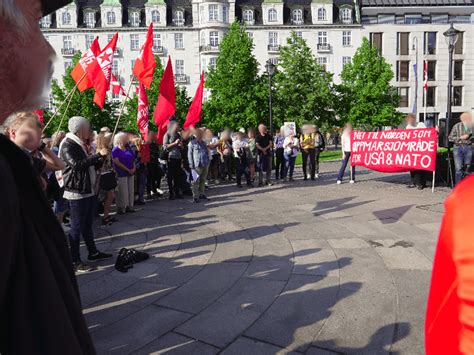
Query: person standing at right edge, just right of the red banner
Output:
[[449, 112, 473, 184]]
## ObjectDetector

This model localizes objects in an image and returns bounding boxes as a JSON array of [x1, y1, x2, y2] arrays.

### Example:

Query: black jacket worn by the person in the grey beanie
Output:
[[61, 138, 104, 195]]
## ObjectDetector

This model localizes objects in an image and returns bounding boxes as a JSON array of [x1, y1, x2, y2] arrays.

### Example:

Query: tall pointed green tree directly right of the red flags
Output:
[[202, 21, 268, 130]]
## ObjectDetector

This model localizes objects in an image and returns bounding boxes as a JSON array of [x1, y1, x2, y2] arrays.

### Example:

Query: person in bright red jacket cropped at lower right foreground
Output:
[[425, 176, 474, 355]]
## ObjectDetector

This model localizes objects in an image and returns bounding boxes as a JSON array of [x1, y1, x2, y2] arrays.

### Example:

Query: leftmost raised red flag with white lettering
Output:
[[71, 37, 100, 92]]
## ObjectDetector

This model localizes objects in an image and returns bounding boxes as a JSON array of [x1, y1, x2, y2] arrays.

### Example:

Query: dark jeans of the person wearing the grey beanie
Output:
[[69, 196, 97, 263]]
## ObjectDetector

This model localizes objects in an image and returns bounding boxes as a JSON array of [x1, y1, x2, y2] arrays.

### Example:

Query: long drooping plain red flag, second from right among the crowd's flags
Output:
[[153, 58, 176, 144]]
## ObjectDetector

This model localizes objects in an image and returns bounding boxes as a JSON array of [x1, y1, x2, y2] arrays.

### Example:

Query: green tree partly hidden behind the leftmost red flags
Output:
[[45, 52, 117, 134]]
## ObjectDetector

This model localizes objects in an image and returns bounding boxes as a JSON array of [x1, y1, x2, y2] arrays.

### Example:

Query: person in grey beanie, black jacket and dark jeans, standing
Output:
[[59, 116, 112, 272]]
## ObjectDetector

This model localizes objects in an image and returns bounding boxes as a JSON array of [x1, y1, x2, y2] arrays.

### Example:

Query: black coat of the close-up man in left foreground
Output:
[[0, 135, 95, 355]]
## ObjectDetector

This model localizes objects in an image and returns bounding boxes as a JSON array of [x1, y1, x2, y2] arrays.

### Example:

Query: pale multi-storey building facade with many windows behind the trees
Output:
[[40, 0, 474, 120]]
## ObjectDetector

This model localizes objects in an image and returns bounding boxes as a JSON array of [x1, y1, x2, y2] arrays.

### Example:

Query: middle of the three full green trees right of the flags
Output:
[[274, 32, 335, 131]]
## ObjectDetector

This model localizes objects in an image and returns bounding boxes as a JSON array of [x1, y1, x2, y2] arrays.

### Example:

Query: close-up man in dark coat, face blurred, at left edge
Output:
[[0, 0, 95, 355]]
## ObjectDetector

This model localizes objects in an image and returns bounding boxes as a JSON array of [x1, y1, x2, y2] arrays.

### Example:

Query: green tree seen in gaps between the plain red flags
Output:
[[119, 56, 191, 133]]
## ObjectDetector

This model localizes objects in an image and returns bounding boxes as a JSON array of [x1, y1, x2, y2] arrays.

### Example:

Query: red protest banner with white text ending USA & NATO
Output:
[[351, 128, 438, 173]]
